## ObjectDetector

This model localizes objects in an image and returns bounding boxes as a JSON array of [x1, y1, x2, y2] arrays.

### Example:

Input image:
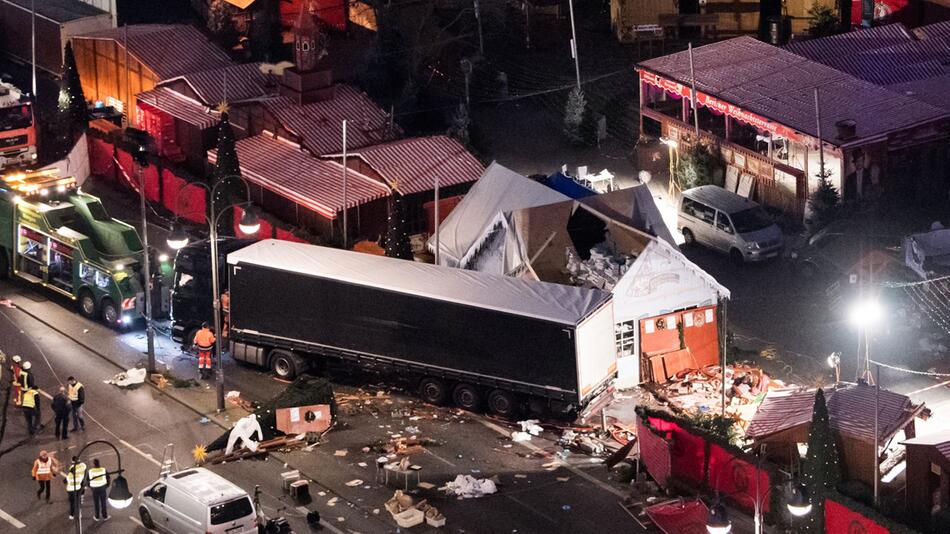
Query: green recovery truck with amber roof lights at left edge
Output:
[[0, 171, 144, 327]]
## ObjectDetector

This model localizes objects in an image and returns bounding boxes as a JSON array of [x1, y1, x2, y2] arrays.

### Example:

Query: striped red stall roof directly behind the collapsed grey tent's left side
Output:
[[331, 135, 485, 195]]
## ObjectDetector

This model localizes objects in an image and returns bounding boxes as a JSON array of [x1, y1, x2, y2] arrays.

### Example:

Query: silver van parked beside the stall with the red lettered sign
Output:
[[676, 185, 785, 263]]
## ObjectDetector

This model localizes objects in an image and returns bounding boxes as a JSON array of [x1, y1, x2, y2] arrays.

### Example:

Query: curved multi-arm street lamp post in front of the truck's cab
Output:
[[168, 175, 261, 412]]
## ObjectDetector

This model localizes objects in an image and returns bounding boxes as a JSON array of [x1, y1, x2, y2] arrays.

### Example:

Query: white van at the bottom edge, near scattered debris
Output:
[[139, 467, 257, 534]]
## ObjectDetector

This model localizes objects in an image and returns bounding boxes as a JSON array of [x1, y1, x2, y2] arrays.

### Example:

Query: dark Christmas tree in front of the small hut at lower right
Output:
[[800, 388, 841, 534]]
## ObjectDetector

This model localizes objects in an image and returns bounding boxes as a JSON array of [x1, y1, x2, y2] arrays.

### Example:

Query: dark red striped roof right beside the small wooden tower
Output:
[[264, 84, 400, 156]]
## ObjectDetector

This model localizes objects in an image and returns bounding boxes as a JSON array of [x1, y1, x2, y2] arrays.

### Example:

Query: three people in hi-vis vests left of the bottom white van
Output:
[[32, 450, 110, 521]]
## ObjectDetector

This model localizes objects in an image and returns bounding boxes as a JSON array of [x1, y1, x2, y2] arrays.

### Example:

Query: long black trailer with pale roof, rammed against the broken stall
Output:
[[226, 240, 616, 417]]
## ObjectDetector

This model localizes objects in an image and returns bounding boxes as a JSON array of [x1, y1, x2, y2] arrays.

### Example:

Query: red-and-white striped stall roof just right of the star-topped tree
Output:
[[208, 134, 389, 219]]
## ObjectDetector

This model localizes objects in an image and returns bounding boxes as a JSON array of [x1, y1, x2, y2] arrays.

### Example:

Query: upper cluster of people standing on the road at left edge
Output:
[[10, 356, 86, 439]]
